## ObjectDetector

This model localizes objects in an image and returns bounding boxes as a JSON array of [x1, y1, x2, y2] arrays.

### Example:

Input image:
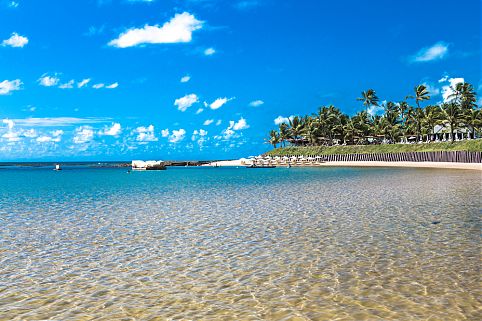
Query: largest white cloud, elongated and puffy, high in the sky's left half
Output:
[[109, 12, 203, 48]]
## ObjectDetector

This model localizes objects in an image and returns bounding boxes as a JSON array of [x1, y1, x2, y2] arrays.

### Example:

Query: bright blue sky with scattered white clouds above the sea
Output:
[[0, 0, 482, 160]]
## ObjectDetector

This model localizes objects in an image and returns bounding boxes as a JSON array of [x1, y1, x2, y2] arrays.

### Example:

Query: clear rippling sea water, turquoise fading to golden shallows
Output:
[[0, 166, 482, 320]]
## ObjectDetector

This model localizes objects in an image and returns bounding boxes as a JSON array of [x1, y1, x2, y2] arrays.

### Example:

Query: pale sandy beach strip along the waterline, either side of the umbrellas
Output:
[[204, 159, 482, 171]]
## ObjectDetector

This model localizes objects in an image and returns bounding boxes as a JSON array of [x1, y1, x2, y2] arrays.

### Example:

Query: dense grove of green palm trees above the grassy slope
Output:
[[267, 83, 482, 149]]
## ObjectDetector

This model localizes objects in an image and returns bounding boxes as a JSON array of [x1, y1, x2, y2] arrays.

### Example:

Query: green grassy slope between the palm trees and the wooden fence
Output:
[[266, 139, 482, 156]]
